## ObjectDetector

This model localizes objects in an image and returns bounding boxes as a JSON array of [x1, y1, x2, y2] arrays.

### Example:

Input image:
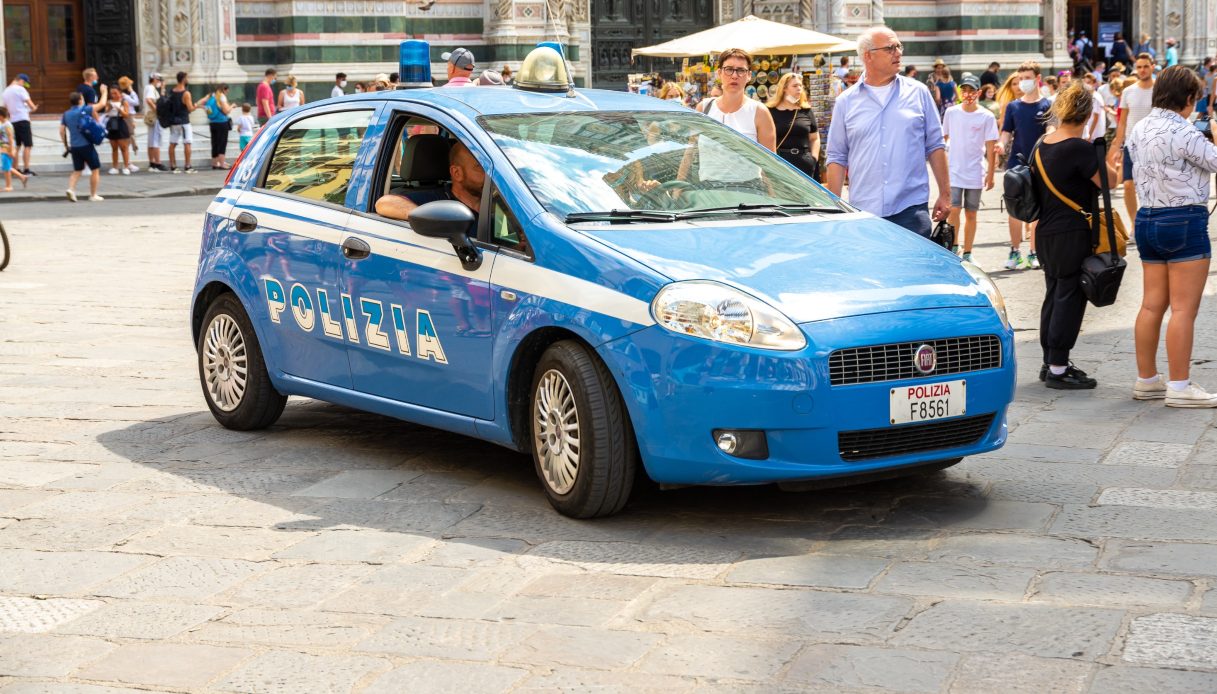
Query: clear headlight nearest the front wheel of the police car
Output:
[[651, 281, 807, 351]]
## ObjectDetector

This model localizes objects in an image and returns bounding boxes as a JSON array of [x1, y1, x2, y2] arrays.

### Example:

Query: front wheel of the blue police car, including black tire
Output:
[[528, 340, 638, 519]]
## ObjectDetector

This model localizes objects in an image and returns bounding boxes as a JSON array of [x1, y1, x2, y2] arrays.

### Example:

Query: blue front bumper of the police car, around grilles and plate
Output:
[[599, 308, 1016, 485]]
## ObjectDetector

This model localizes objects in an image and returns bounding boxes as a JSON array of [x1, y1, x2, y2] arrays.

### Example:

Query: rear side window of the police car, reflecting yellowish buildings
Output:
[[262, 110, 374, 205]]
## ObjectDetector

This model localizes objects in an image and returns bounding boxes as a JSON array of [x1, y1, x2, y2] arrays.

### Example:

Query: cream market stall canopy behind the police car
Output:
[[629, 15, 858, 57]]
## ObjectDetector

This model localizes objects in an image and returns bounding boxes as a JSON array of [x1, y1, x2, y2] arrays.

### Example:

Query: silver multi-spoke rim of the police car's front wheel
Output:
[[533, 369, 581, 494]]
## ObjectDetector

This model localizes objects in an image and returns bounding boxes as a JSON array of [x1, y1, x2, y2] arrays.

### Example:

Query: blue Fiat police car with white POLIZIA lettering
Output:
[[192, 49, 1015, 517]]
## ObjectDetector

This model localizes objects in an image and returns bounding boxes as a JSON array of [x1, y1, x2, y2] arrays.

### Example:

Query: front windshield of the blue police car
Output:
[[478, 112, 843, 220]]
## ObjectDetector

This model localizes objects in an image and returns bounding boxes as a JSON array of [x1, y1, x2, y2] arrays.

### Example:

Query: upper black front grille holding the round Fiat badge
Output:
[[829, 335, 1002, 386]]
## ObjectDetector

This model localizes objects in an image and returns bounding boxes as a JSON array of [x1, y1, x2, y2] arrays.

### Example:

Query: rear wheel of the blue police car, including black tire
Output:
[[196, 293, 287, 431]]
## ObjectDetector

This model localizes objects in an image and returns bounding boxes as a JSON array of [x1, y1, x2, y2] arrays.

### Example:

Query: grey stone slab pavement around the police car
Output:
[[0, 194, 1217, 694]]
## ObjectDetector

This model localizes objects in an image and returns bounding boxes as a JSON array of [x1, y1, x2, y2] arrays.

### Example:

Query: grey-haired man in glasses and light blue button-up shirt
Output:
[[828, 27, 950, 237]]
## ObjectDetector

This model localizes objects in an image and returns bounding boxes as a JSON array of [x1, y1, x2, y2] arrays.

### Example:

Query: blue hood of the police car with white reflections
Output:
[[579, 213, 989, 323]]
